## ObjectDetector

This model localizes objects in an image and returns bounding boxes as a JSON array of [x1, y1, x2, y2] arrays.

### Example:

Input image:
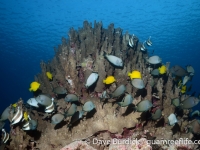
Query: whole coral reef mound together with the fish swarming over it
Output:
[[0, 21, 200, 150]]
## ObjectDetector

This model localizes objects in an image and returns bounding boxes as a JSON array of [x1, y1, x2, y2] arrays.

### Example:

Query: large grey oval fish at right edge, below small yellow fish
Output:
[[180, 97, 200, 109]]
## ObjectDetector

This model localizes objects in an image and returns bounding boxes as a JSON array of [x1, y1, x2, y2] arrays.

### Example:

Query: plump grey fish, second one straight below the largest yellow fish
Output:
[[135, 100, 153, 112]]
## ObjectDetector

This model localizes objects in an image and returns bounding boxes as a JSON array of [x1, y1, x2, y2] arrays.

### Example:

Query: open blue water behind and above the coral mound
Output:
[[0, 0, 200, 118]]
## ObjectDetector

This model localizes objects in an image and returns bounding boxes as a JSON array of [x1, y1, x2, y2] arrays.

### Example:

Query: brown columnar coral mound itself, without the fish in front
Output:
[[1, 21, 199, 150]]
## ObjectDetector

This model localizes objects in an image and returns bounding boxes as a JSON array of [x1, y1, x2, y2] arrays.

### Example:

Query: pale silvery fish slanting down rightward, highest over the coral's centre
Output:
[[104, 51, 123, 67]]
